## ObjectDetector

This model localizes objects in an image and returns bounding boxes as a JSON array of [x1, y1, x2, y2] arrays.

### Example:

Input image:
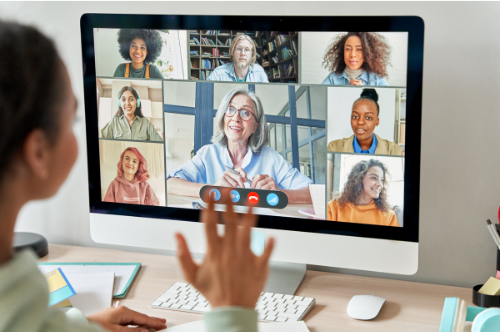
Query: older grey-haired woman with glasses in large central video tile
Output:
[[167, 88, 312, 203]]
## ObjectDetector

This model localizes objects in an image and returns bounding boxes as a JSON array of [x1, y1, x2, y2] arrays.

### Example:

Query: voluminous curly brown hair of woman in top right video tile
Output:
[[322, 32, 391, 77]]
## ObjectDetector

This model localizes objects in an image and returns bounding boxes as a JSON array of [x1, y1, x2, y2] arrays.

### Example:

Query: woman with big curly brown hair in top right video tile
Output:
[[323, 32, 391, 86]]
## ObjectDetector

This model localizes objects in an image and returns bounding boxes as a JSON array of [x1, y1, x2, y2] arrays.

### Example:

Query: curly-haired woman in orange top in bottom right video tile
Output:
[[327, 159, 399, 227]]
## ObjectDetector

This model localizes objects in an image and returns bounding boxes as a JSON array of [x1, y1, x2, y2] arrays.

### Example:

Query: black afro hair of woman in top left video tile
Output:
[[118, 29, 163, 64]]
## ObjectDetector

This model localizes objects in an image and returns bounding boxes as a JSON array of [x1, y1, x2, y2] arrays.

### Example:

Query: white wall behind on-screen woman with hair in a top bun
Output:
[[326, 87, 396, 142]]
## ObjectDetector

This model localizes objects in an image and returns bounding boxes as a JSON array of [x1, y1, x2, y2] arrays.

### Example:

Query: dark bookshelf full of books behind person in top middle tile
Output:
[[188, 30, 299, 83]]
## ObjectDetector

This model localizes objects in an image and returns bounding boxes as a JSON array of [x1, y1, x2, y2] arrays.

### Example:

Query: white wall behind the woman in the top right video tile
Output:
[[300, 32, 408, 86]]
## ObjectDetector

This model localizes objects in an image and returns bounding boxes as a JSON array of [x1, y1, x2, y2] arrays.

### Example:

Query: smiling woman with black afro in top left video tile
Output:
[[113, 29, 163, 79]]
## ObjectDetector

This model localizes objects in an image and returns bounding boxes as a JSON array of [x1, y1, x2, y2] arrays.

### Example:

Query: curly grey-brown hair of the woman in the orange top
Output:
[[338, 159, 389, 212]]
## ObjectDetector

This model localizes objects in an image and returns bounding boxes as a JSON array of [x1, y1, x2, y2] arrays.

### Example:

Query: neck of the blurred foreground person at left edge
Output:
[[0, 177, 28, 266]]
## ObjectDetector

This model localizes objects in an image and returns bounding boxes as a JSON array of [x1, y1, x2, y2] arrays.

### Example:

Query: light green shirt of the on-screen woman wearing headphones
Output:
[[101, 115, 163, 141]]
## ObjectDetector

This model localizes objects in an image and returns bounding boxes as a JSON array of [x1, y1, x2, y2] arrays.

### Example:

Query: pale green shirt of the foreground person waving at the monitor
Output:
[[0, 249, 257, 332]]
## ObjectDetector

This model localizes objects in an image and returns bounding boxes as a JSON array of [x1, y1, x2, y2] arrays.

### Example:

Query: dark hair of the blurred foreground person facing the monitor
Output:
[[0, 21, 65, 182]]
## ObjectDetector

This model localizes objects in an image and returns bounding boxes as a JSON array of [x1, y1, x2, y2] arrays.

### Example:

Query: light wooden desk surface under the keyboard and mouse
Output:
[[40, 245, 472, 332]]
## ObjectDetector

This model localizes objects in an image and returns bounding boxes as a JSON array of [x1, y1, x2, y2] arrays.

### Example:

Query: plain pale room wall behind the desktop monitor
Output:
[[0, 2, 500, 287]]
